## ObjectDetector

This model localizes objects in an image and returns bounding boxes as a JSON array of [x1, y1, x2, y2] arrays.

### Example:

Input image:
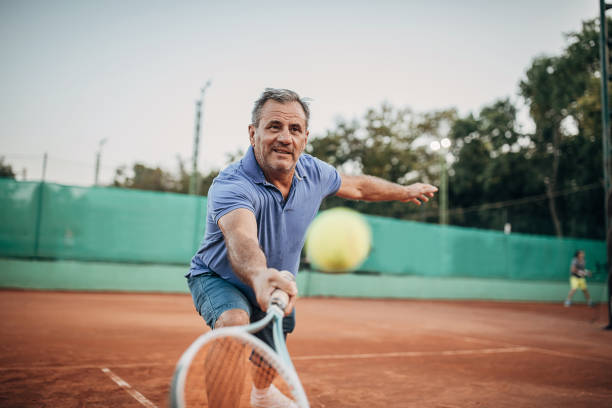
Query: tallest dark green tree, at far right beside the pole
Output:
[[519, 20, 604, 238]]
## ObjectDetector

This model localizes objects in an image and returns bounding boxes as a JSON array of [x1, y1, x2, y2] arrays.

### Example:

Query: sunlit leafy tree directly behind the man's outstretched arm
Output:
[[306, 103, 444, 220]]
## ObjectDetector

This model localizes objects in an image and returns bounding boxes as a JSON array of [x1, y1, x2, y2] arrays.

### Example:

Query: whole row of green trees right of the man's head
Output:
[[308, 20, 604, 239]]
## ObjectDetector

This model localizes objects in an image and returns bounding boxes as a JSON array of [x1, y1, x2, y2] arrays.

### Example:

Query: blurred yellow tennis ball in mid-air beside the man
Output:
[[306, 207, 372, 273]]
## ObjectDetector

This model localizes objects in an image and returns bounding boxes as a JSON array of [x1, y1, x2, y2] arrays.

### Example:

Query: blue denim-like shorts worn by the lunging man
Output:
[[187, 272, 295, 348]]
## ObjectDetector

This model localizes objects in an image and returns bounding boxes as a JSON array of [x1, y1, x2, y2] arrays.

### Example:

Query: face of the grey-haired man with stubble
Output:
[[249, 100, 308, 175]]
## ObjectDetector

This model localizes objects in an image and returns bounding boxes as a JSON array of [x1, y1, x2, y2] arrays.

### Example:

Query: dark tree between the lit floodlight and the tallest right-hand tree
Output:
[[449, 98, 541, 232]]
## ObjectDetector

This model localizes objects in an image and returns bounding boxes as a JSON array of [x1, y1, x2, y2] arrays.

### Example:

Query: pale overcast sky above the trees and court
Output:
[[0, 0, 599, 185]]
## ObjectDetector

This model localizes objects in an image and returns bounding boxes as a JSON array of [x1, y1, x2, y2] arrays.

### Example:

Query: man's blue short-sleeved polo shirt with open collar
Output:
[[188, 147, 341, 301]]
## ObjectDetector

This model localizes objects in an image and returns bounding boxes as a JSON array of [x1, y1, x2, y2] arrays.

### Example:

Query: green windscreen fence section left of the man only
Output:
[[0, 179, 206, 264]]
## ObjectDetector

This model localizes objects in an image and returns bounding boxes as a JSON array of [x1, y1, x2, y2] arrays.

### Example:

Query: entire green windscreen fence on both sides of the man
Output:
[[0, 179, 606, 282]]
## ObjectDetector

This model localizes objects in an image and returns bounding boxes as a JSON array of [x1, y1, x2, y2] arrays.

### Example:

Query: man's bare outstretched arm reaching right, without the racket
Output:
[[336, 174, 438, 205]]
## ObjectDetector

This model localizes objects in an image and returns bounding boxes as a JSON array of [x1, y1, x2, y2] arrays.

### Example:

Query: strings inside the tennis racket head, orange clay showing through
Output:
[[184, 337, 292, 408]]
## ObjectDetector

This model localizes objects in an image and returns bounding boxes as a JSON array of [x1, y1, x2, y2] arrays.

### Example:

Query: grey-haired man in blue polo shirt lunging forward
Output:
[[187, 88, 437, 408]]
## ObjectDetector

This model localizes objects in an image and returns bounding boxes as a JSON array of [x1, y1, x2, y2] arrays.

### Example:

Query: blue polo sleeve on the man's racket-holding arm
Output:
[[207, 179, 255, 224]]
